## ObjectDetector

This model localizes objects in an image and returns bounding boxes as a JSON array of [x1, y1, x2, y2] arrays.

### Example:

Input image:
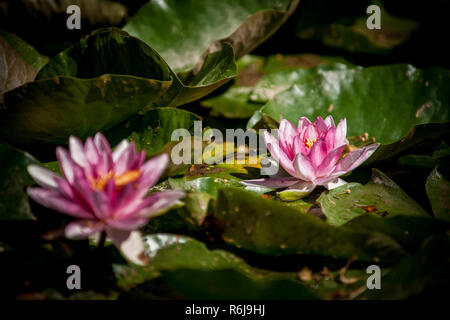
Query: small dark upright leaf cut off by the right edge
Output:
[[425, 168, 450, 222]]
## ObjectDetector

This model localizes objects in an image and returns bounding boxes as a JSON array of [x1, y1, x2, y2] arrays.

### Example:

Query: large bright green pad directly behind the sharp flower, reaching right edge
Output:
[[248, 64, 450, 159]]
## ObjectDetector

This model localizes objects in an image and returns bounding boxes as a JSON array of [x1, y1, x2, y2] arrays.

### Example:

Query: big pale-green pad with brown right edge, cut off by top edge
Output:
[[123, 0, 298, 72]]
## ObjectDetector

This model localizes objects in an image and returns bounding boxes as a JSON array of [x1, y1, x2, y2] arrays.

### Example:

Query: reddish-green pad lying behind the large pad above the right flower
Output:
[[201, 54, 349, 119]]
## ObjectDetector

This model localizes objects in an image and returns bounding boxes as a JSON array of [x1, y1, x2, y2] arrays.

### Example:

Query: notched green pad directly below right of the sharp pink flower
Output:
[[317, 169, 429, 227]]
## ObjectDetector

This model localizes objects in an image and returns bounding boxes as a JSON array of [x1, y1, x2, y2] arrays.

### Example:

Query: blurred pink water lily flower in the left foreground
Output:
[[27, 133, 184, 245]]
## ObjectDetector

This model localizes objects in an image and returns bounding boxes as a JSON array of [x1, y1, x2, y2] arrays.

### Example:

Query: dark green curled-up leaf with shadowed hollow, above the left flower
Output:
[[0, 29, 171, 145]]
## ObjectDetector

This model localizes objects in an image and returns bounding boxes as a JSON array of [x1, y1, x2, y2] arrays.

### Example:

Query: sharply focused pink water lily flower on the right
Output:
[[245, 115, 379, 195]]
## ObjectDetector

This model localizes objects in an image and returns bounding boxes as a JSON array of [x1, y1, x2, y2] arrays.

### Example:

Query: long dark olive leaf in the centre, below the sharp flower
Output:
[[214, 188, 404, 261]]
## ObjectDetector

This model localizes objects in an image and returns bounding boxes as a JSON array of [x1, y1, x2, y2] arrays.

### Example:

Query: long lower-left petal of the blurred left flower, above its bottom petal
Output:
[[27, 188, 94, 219]]
